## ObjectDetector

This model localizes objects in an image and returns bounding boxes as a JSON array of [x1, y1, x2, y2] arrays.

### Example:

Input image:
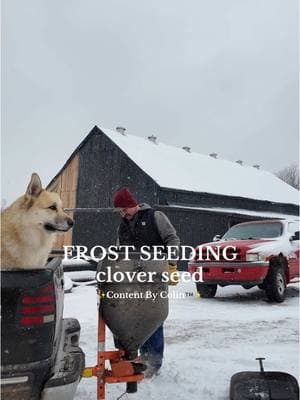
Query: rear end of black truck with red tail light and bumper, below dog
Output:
[[1, 258, 84, 400]]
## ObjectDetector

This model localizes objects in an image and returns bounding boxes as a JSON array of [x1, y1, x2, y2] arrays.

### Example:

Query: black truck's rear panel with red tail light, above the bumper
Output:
[[1, 259, 63, 367]]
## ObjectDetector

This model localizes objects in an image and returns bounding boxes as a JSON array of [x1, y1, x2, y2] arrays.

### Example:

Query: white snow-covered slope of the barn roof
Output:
[[100, 128, 299, 204]]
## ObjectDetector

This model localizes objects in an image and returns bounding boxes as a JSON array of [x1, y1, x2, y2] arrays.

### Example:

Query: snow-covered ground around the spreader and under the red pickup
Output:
[[65, 276, 299, 400]]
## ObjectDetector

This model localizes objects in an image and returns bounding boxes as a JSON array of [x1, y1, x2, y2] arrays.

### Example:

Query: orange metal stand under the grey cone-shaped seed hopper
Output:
[[83, 293, 144, 400]]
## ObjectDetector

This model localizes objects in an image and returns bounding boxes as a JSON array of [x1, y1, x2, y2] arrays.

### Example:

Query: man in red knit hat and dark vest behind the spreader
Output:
[[113, 187, 180, 377]]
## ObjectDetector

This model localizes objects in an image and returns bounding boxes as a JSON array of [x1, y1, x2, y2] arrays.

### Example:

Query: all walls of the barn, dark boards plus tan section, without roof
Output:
[[47, 128, 299, 258]]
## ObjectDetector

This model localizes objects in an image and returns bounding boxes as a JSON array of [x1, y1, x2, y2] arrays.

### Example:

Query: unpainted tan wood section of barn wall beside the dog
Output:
[[49, 154, 79, 249]]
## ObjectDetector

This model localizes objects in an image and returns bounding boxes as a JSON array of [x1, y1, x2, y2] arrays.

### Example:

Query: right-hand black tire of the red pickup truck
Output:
[[264, 265, 286, 303]]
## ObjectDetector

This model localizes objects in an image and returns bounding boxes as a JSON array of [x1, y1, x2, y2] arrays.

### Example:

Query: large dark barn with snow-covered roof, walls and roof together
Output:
[[48, 126, 299, 268]]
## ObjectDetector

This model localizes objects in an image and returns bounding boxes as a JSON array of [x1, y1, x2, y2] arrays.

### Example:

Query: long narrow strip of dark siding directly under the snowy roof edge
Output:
[[158, 188, 299, 215]]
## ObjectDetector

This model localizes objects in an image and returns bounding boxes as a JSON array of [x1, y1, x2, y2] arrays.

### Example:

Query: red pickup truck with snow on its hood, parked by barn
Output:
[[188, 218, 299, 302]]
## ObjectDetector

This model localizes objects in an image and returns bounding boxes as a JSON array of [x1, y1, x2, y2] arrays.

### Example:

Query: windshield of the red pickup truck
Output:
[[222, 222, 282, 240]]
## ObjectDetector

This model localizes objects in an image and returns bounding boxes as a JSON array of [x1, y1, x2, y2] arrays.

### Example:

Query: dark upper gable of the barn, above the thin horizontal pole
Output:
[[77, 131, 157, 207]]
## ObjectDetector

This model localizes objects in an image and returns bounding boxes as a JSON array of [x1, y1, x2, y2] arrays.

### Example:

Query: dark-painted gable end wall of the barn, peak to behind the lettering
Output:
[[73, 131, 158, 247]]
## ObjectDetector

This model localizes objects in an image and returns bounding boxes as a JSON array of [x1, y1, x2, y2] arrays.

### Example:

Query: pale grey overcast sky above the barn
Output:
[[1, 0, 298, 201]]
